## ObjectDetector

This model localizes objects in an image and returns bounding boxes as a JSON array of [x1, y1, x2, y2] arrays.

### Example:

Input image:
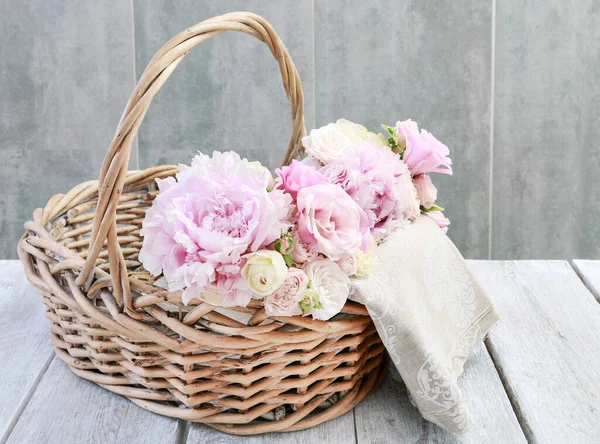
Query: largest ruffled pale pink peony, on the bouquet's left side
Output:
[[139, 151, 291, 306]]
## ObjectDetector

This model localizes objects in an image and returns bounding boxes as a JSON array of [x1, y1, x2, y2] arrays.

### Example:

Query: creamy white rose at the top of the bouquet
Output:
[[302, 119, 387, 164]]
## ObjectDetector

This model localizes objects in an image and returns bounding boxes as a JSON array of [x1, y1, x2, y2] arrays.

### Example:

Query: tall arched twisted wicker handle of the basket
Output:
[[76, 12, 306, 314]]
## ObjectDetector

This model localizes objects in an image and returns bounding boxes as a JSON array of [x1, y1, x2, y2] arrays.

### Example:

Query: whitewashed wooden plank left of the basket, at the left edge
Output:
[[0, 261, 53, 443]]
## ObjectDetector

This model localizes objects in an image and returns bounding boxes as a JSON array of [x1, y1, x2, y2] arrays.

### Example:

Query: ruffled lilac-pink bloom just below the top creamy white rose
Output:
[[321, 142, 419, 229]]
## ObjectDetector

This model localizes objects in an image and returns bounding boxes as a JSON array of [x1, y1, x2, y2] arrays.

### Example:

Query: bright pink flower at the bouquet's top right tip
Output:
[[396, 120, 452, 176]]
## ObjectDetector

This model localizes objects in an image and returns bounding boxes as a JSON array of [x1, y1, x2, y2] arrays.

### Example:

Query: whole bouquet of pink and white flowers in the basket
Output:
[[139, 119, 452, 320]]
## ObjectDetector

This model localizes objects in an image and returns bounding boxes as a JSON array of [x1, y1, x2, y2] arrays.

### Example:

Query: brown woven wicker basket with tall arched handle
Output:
[[18, 13, 388, 434]]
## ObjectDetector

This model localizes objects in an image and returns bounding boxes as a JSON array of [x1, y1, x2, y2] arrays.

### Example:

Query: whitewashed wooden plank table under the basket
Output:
[[0, 261, 600, 444]]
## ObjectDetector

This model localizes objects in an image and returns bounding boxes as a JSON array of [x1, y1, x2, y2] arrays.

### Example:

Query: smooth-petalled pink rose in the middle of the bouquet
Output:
[[296, 184, 371, 260]]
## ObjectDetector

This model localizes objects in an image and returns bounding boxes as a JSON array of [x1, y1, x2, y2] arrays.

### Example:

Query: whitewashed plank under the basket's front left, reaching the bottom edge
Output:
[[8, 358, 178, 444]]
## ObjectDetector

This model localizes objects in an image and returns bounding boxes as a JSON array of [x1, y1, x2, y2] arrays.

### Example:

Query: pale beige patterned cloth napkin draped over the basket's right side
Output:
[[350, 216, 500, 434]]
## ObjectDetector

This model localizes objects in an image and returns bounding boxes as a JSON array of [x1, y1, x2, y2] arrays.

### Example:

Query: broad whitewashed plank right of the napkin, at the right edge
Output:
[[471, 261, 600, 444]]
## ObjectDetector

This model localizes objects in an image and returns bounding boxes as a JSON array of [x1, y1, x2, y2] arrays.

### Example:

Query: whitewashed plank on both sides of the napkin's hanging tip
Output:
[[354, 342, 526, 444]]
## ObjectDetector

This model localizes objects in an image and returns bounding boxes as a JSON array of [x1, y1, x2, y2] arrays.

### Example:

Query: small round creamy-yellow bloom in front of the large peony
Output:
[[242, 250, 287, 296]]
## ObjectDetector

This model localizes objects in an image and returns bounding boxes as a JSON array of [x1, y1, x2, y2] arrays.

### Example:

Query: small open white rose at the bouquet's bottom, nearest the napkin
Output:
[[301, 259, 350, 321]]
